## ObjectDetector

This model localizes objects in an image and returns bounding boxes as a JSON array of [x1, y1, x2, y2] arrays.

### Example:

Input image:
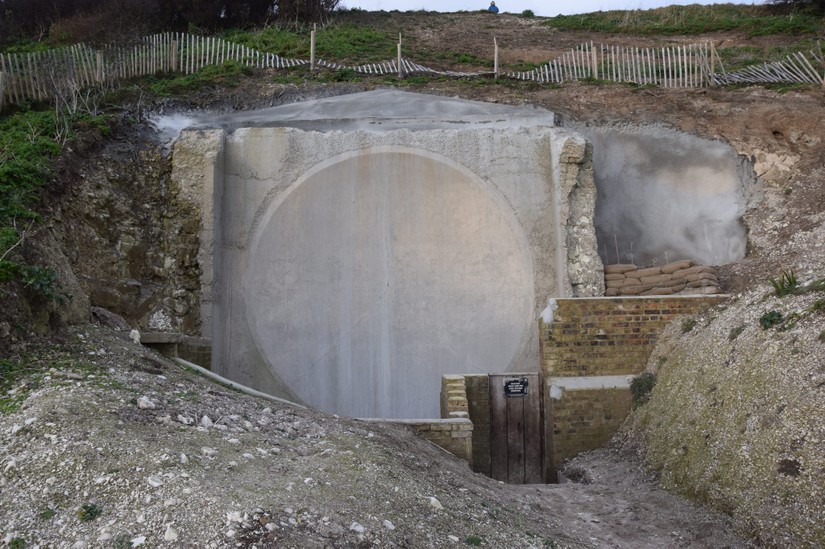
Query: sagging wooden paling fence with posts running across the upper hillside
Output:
[[0, 30, 825, 109]]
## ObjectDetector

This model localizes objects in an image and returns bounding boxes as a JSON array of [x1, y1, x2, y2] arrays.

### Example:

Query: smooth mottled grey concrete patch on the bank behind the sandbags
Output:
[[570, 124, 754, 265]]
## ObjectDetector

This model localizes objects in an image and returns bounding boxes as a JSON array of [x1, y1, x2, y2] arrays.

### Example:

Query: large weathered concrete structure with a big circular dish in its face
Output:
[[175, 92, 602, 418]]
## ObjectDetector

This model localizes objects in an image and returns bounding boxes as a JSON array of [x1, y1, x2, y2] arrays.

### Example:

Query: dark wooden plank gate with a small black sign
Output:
[[490, 373, 545, 484]]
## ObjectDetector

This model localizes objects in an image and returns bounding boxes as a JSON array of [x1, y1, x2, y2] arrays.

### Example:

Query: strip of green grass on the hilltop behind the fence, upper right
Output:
[[546, 4, 825, 37]]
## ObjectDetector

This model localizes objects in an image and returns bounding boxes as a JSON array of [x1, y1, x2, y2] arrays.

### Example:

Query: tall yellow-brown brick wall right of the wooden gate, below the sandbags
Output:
[[539, 296, 726, 469]]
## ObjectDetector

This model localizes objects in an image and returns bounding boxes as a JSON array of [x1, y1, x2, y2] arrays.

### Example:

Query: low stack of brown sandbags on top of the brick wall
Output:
[[604, 259, 722, 296]]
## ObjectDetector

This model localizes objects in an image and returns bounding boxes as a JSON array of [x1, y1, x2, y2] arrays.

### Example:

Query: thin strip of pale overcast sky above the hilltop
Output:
[[341, 0, 762, 17]]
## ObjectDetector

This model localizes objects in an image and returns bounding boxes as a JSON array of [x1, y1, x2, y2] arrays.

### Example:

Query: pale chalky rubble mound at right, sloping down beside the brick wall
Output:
[[620, 268, 825, 547]]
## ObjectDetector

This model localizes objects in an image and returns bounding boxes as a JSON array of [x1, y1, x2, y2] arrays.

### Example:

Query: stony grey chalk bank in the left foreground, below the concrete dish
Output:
[[0, 326, 747, 548]]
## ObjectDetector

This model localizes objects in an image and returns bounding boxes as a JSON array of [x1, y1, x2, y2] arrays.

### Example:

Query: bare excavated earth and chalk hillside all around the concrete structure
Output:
[[0, 9, 825, 547]]
